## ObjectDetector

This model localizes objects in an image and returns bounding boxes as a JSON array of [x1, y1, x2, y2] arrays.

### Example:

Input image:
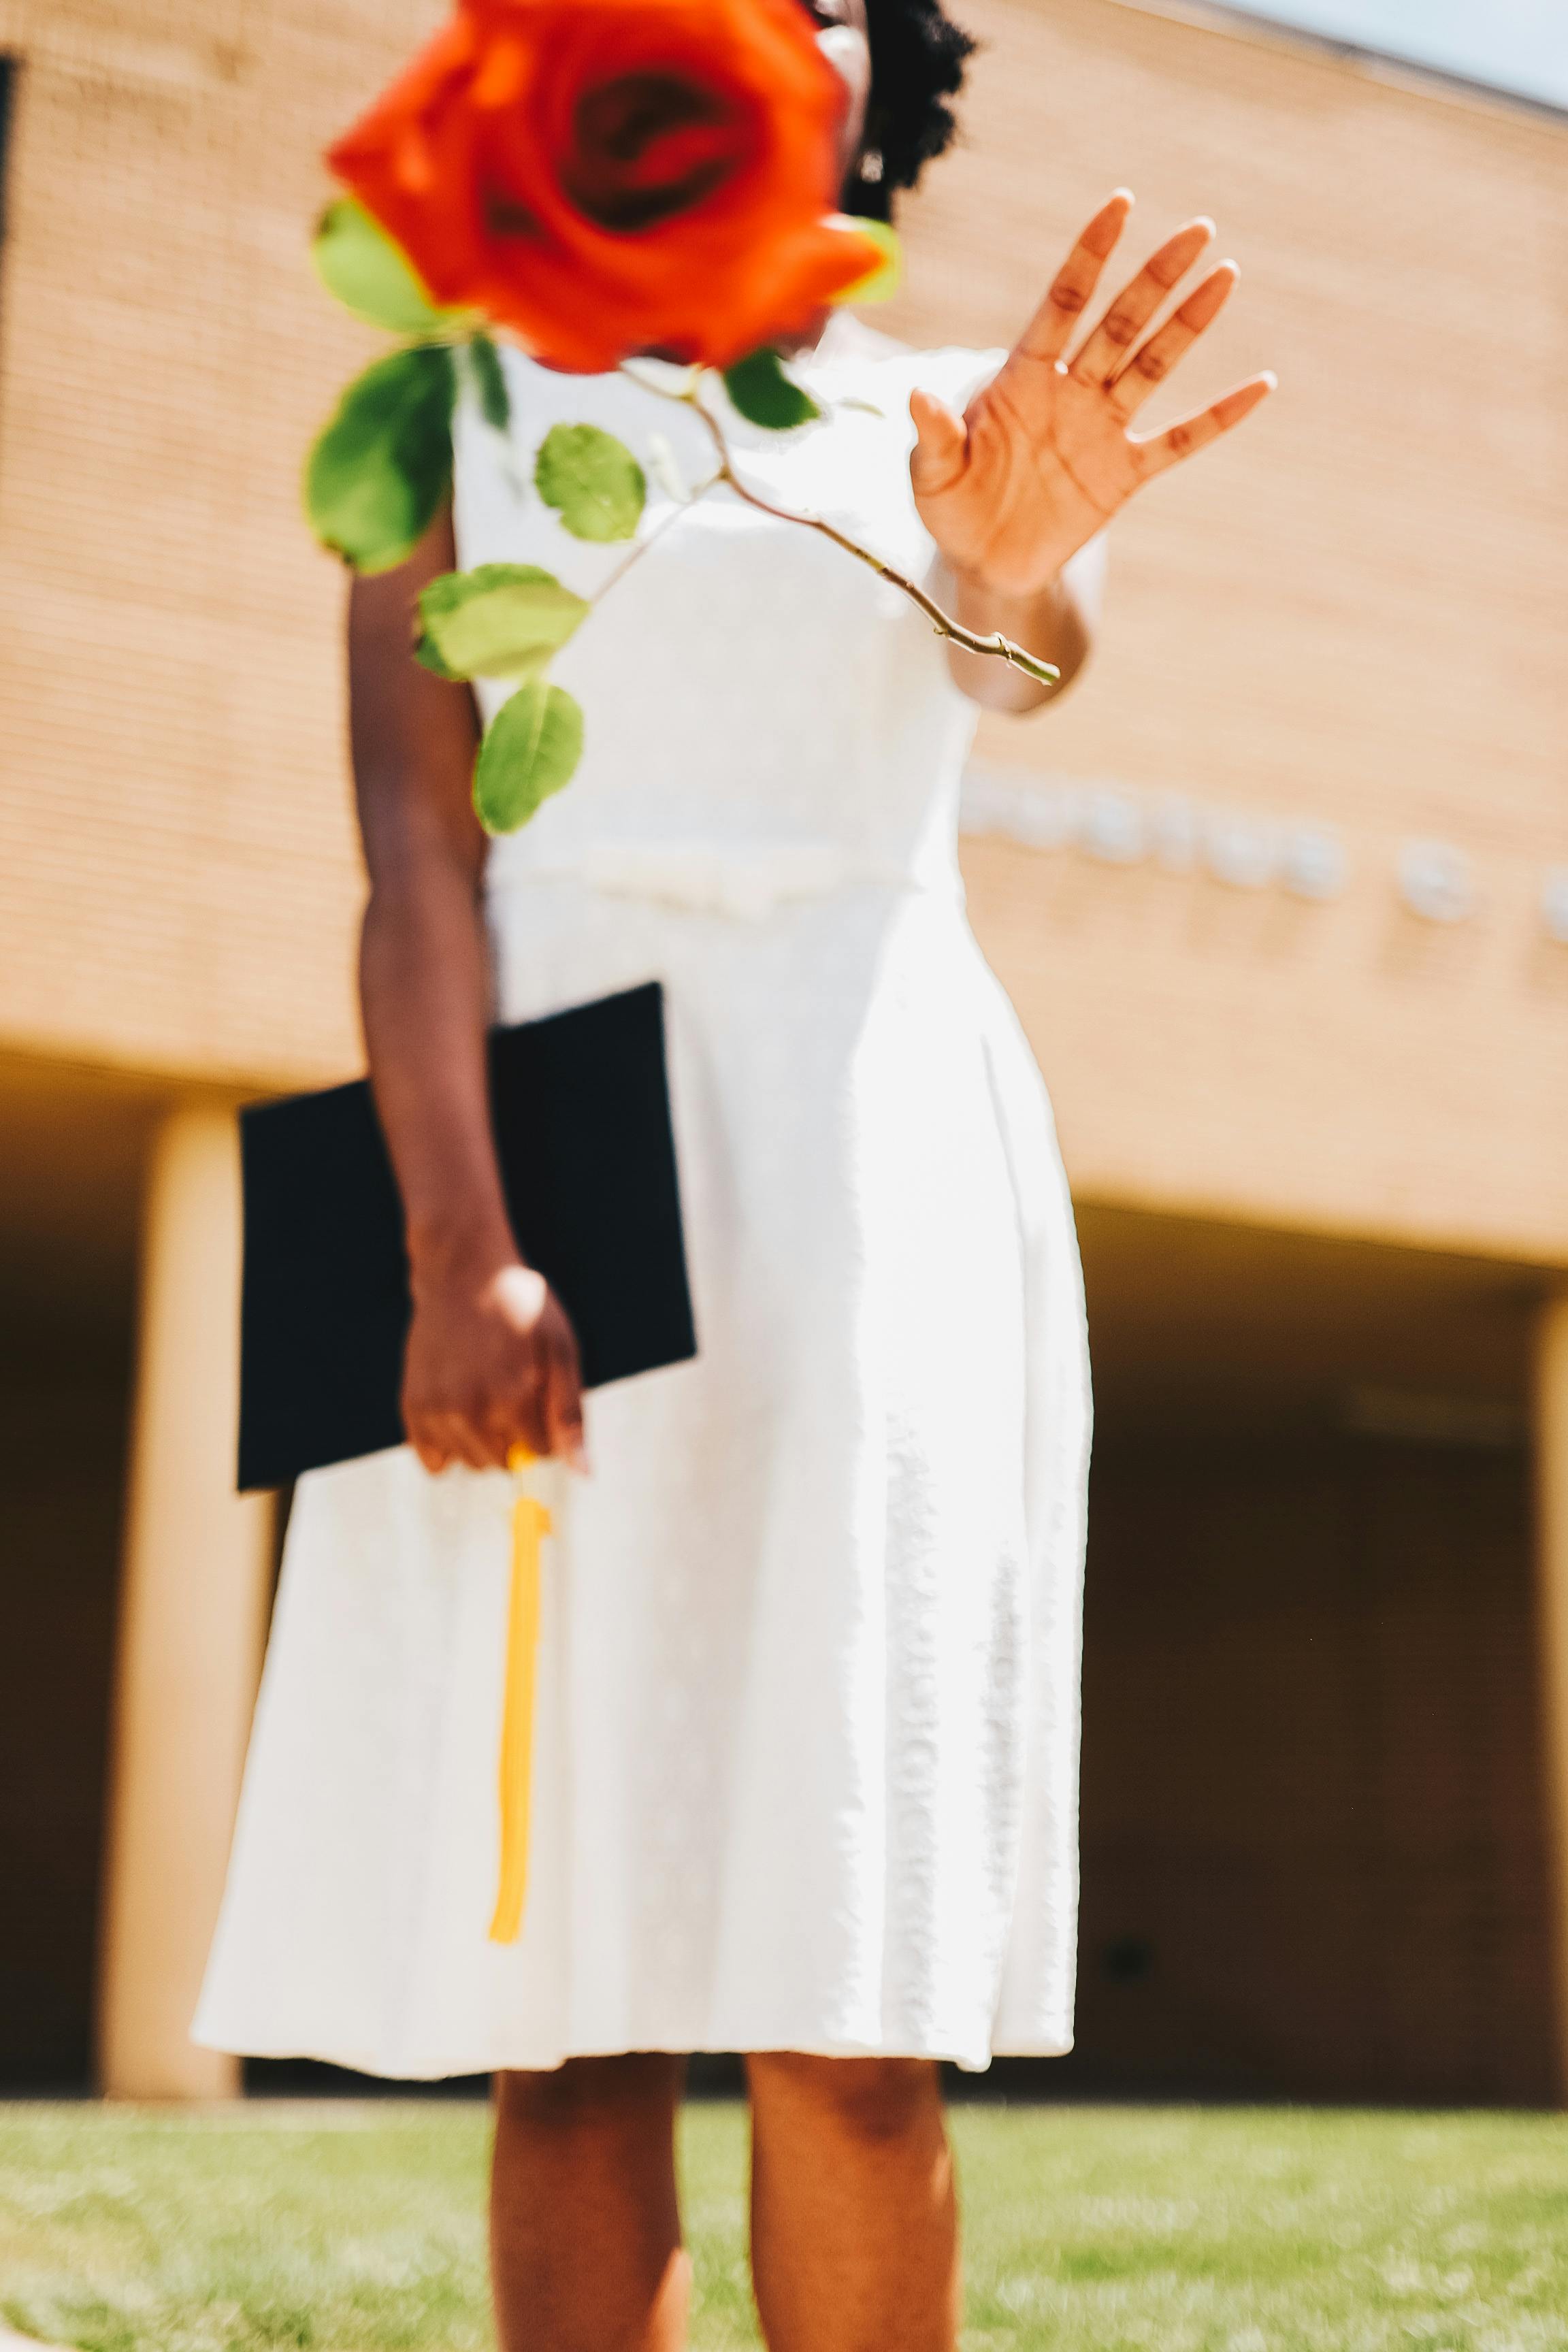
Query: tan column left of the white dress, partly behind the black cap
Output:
[[99, 1103, 273, 2098]]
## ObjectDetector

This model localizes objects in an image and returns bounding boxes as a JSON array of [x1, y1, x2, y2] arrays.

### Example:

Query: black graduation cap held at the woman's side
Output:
[[240, 981, 696, 1491]]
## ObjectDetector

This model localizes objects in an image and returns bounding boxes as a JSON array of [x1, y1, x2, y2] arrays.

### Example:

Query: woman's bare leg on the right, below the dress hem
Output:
[[747, 2051, 962, 2352]]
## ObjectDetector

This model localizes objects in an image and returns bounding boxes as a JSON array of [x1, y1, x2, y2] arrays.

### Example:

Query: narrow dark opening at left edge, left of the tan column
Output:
[[0, 1068, 146, 2091]]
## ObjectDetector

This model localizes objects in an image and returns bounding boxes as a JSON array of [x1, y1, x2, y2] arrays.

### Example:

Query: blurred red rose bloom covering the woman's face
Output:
[[327, 0, 881, 374]]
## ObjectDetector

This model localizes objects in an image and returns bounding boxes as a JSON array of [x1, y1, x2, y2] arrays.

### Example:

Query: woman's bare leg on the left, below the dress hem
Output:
[[489, 2051, 691, 2352]]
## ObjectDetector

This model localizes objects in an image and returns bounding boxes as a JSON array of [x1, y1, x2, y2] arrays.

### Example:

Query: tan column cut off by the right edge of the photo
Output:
[[1535, 1289, 1568, 2103]]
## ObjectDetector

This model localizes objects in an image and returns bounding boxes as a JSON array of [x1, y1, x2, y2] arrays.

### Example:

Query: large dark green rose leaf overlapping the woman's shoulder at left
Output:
[[306, 346, 456, 572]]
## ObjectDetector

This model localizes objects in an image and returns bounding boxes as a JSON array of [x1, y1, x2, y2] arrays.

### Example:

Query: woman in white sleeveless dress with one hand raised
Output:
[[197, 0, 1267, 2352]]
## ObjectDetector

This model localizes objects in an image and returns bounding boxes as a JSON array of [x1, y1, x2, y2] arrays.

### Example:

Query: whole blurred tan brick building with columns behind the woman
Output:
[[0, 0, 1568, 2100]]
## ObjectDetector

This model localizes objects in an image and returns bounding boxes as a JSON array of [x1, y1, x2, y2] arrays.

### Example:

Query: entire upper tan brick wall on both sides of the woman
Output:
[[0, 0, 1568, 1260]]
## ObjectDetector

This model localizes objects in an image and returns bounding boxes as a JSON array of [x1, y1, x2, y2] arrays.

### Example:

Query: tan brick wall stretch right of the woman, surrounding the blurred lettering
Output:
[[883, 0, 1568, 1263]]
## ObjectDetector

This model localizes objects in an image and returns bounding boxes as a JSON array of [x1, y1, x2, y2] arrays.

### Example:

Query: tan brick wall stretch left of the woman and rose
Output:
[[0, 0, 440, 1082]]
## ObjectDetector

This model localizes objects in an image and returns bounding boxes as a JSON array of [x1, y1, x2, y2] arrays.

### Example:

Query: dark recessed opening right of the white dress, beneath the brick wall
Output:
[[1051, 1213, 1554, 2103]]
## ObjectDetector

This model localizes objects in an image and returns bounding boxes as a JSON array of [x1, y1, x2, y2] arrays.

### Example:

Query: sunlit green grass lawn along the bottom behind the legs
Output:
[[0, 2103, 1568, 2352]]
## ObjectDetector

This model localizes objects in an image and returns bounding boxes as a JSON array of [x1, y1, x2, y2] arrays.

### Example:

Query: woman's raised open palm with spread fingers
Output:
[[910, 191, 1274, 598]]
